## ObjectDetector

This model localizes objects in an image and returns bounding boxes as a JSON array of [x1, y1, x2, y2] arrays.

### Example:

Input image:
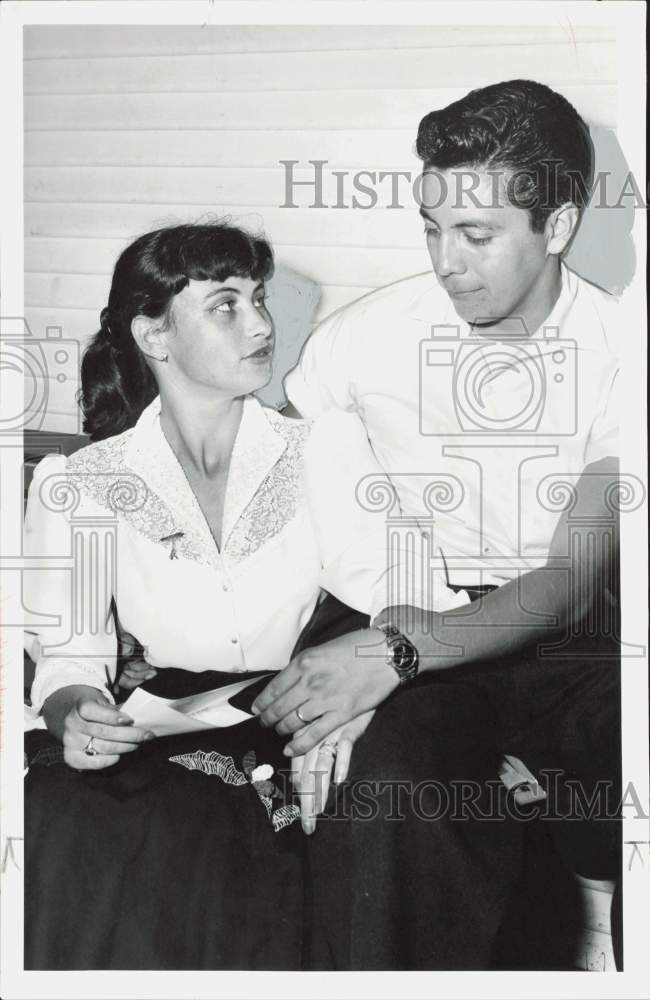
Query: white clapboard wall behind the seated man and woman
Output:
[[25, 25, 617, 430]]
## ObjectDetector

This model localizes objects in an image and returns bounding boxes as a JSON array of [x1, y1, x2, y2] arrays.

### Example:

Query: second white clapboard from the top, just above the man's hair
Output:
[[25, 40, 615, 95]]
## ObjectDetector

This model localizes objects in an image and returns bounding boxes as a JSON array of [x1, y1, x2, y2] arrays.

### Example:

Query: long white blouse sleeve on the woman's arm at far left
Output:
[[23, 455, 117, 712]]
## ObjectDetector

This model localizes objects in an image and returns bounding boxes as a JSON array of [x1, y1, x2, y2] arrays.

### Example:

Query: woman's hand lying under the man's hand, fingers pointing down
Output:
[[291, 709, 375, 834]]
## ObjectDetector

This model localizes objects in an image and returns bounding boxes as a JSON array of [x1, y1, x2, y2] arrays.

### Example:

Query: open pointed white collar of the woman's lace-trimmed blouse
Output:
[[126, 396, 286, 550]]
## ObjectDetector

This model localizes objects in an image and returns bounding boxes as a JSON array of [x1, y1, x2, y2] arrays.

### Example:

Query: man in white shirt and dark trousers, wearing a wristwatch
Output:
[[251, 80, 622, 968]]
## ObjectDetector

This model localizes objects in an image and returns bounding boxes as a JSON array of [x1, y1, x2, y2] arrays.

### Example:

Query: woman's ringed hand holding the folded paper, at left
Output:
[[43, 685, 154, 771]]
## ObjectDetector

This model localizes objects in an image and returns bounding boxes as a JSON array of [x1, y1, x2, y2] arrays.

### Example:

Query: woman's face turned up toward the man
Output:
[[165, 277, 274, 398]]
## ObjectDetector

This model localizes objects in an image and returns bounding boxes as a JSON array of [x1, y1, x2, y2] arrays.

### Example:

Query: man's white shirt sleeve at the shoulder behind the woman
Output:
[[284, 306, 358, 419]]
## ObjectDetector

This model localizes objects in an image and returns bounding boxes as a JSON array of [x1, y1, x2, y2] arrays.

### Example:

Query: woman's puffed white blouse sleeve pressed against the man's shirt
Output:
[[305, 411, 468, 618]]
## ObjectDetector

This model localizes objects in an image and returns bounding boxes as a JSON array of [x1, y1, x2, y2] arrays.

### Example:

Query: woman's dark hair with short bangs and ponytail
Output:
[[79, 222, 273, 441]]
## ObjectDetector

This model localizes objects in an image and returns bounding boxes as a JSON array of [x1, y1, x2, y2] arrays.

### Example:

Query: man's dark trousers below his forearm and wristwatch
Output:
[[301, 601, 621, 969]]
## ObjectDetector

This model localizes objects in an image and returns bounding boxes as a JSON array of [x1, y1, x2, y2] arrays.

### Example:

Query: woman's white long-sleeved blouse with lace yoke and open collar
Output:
[[24, 397, 463, 711]]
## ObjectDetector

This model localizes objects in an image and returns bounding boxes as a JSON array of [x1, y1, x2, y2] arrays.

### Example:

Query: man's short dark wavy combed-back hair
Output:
[[416, 80, 594, 232]]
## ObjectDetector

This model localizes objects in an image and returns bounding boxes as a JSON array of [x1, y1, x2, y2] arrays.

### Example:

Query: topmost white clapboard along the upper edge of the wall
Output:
[[25, 24, 614, 59]]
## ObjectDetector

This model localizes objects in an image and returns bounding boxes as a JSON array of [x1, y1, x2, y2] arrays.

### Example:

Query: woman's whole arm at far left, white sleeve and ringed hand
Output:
[[23, 455, 154, 769]]
